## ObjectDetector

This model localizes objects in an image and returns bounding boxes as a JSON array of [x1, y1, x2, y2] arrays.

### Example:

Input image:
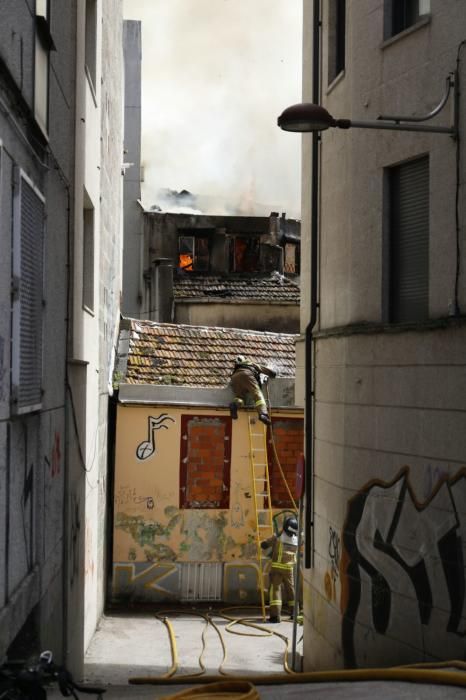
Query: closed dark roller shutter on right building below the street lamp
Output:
[[390, 157, 429, 322]]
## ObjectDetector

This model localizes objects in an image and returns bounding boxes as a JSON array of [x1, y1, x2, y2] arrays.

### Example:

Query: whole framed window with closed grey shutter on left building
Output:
[[12, 172, 45, 413]]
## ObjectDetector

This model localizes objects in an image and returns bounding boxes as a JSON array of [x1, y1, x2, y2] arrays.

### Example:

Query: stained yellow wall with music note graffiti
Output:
[[112, 402, 302, 604]]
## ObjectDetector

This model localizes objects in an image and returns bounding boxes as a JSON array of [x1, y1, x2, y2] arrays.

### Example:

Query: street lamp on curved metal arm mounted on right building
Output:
[[277, 73, 458, 138]]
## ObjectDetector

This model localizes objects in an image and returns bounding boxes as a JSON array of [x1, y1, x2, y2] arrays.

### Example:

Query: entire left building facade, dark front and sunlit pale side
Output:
[[0, 0, 123, 675]]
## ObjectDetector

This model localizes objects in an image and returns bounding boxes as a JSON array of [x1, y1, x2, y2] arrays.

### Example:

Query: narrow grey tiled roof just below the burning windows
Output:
[[173, 273, 299, 304]]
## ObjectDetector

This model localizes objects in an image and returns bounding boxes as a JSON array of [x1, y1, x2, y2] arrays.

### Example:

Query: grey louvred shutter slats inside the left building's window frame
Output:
[[17, 178, 44, 409]]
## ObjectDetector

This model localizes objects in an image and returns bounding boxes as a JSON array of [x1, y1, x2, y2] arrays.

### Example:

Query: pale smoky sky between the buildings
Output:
[[124, 0, 302, 218]]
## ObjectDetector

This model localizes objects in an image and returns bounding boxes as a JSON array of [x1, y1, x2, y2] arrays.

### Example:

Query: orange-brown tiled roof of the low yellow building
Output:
[[122, 319, 298, 387]]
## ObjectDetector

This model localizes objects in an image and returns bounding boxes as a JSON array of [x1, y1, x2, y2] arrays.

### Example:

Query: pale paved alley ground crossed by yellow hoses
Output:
[[73, 608, 466, 700]]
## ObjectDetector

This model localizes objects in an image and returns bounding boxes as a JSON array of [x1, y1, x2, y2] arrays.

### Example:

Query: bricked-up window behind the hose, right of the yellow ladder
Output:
[[267, 418, 304, 508]]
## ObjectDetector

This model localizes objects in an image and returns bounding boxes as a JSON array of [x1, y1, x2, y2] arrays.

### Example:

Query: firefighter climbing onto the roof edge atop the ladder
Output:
[[230, 355, 276, 425]]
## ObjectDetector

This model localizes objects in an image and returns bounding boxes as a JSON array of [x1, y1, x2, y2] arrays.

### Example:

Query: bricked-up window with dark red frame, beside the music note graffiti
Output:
[[180, 415, 231, 508]]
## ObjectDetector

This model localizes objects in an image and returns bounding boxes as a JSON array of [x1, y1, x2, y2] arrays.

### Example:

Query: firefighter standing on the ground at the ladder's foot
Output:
[[261, 515, 298, 622]]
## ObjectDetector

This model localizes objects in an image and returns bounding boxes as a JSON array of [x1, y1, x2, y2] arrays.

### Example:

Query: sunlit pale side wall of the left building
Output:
[[68, 0, 124, 675]]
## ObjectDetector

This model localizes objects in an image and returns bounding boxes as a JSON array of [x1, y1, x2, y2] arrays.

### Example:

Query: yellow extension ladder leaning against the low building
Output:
[[248, 412, 273, 620]]
